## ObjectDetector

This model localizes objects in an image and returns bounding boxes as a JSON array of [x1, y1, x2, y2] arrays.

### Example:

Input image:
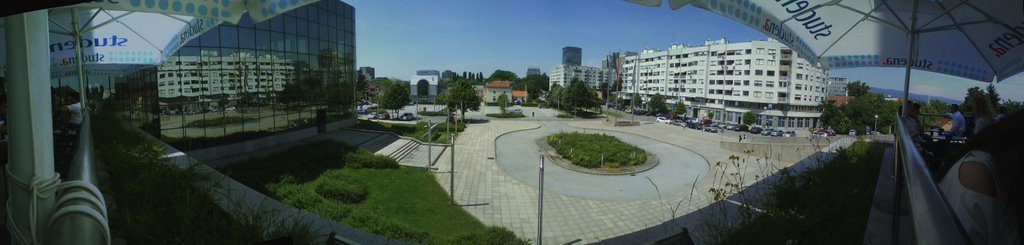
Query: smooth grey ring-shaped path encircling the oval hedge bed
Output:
[[495, 122, 709, 201]]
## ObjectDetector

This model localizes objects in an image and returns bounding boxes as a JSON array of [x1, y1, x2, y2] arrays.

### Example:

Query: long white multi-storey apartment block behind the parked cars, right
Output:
[[620, 39, 828, 128]]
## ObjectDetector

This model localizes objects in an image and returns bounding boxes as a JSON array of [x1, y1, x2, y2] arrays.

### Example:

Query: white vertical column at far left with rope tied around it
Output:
[[4, 10, 60, 244]]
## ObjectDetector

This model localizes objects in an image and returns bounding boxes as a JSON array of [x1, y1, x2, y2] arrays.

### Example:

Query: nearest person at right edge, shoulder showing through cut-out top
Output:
[[935, 113, 1024, 244]]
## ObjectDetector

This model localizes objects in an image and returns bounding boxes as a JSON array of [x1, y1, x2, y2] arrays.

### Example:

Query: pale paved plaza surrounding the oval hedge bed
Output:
[[423, 110, 848, 244]]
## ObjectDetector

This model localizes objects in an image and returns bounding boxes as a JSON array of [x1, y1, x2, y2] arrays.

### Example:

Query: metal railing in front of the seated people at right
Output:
[[892, 116, 971, 244]]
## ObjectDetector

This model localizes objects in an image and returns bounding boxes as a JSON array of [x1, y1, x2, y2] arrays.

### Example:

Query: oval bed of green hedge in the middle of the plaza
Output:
[[547, 132, 647, 168]]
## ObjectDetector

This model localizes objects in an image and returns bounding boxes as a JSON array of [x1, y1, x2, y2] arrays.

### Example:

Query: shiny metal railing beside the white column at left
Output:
[[47, 113, 111, 244]]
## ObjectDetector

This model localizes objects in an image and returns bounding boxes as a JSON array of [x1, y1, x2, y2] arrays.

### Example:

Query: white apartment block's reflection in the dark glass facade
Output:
[[157, 50, 295, 101]]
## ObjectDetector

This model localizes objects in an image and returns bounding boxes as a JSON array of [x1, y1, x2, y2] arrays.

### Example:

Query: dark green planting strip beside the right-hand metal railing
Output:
[[720, 141, 885, 244]]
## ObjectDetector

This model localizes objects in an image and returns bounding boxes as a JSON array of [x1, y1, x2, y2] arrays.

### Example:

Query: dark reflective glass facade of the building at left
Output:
[[106, 0, 357, 147]]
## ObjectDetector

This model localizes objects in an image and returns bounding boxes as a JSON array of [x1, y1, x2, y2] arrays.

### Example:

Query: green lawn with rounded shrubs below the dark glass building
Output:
[[222, 140, 525, 244]]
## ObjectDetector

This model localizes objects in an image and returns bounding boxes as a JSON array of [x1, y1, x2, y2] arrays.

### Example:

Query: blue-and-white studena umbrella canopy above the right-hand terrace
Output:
[[627, 0, 1024, 82]]
